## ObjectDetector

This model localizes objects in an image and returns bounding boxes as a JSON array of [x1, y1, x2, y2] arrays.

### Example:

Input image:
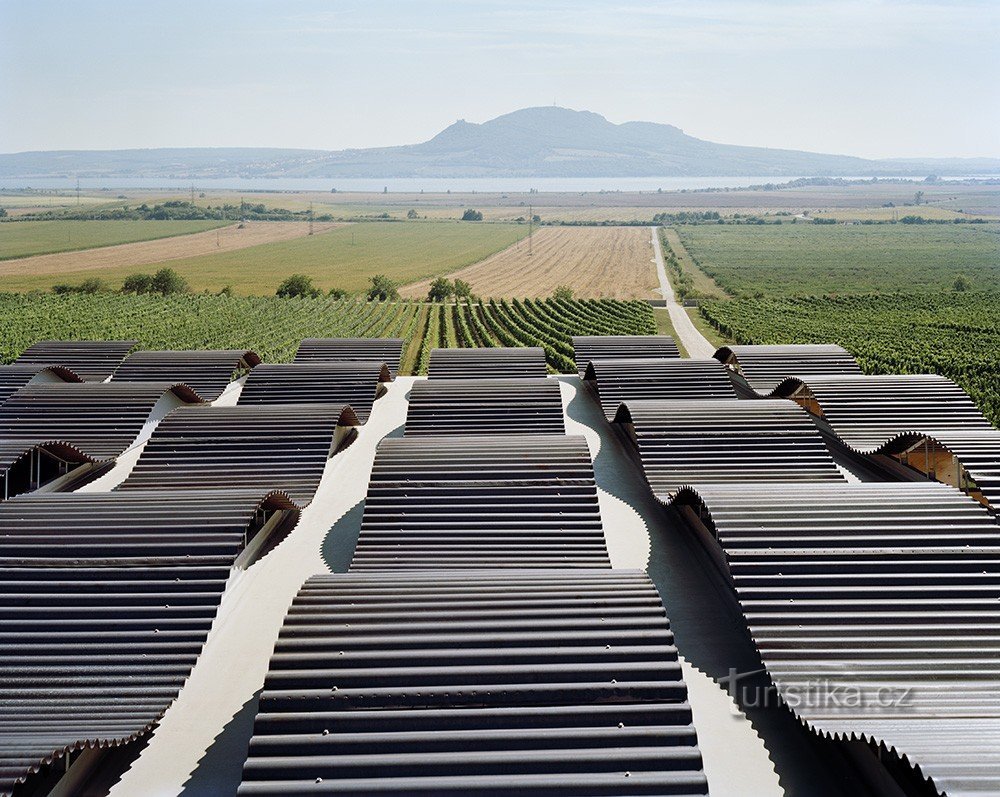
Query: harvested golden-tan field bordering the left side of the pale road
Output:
[[400, 227, 658, 299]]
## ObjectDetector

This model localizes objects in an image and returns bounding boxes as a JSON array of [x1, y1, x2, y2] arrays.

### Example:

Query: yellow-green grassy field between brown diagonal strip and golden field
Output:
[[3, 222, 527, 295]]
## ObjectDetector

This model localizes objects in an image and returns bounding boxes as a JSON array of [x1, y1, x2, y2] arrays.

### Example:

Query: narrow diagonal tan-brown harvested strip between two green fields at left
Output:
[[0, 221, 343, 290]]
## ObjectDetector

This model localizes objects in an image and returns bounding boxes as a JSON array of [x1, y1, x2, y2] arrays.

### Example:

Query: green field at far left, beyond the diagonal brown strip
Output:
[[0, 221, 226, 260]]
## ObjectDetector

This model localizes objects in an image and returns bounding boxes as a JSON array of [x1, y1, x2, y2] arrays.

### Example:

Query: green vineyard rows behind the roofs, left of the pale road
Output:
[[0, 294, 656, 373]]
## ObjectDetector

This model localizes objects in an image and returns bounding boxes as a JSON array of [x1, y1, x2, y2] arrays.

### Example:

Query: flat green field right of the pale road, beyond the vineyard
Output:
[[678, 222, 1000, 297]]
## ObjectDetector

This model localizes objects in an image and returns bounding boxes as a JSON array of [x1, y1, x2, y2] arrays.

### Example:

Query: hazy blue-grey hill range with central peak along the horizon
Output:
[[0, 106, 1000, 179]]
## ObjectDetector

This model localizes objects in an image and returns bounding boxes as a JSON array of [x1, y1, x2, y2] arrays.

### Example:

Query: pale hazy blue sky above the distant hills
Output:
[[0, 0, 1000, 157]]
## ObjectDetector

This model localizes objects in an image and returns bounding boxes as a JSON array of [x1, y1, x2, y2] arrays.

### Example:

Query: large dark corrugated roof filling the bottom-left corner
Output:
[[0, 491, 294, 794]]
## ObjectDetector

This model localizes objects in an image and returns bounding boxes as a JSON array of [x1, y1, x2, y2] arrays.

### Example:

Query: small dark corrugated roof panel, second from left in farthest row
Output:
[[112, 349, 260, 401]]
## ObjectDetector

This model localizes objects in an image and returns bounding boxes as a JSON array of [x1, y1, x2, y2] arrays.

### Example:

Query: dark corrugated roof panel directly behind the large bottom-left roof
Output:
[[119, 404, 358, 505]]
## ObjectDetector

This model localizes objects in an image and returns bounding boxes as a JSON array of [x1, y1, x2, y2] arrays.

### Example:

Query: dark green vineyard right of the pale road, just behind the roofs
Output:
[[701, 293, 1000, 423]]
